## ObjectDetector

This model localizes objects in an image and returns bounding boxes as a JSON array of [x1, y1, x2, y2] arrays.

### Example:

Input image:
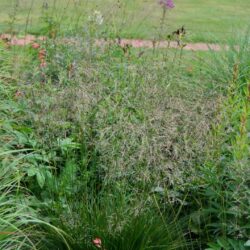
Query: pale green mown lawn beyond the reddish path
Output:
[[0, 0, 250, 42]]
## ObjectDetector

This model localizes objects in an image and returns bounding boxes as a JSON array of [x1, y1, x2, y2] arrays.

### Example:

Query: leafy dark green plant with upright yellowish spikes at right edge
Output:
[[182, 42, 250, 249]]
